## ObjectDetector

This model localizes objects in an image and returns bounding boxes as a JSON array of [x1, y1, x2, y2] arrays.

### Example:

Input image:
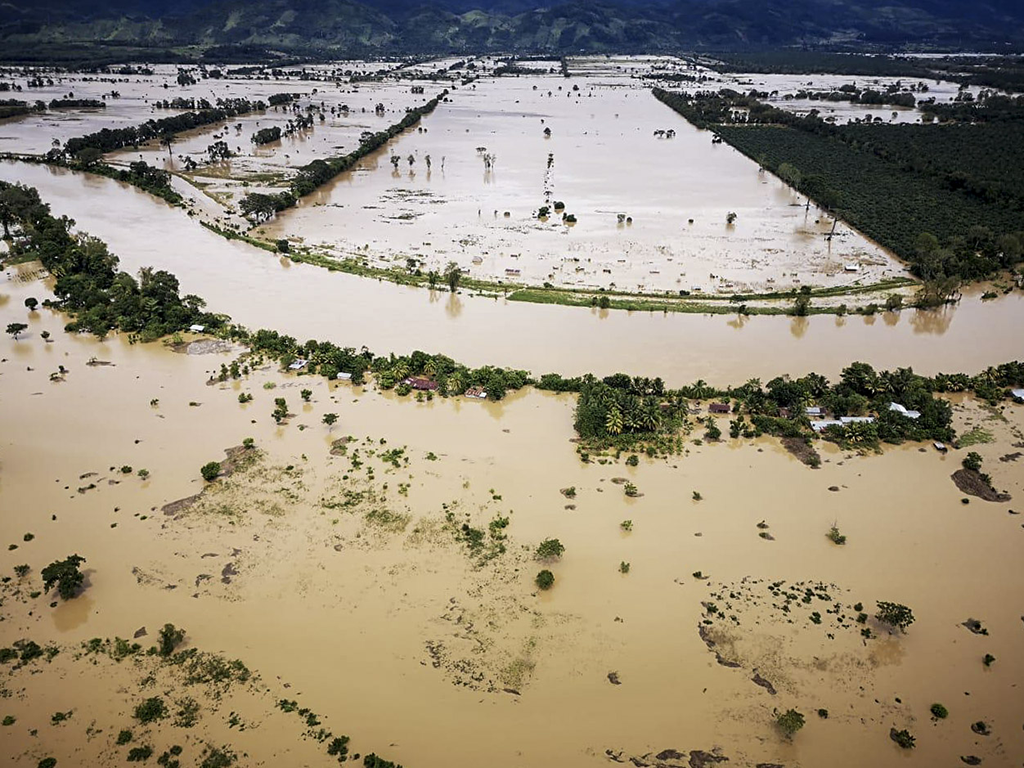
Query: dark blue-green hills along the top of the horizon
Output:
[[0, 0, 1024, 59]]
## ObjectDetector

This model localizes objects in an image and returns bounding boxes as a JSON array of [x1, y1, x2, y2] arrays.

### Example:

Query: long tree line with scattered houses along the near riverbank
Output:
[[0, 181, 1024, 423]]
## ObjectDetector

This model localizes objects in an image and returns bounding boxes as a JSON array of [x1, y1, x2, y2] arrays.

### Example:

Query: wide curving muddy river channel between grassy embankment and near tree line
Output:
[[0, 158, 1024, 385]]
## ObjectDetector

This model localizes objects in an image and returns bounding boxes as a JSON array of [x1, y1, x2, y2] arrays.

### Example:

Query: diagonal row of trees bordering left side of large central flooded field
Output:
[[239, 96, 447, 221]]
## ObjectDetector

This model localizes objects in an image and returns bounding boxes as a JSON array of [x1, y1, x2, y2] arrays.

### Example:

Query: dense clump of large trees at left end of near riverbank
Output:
[[0, 181, 223, 340]]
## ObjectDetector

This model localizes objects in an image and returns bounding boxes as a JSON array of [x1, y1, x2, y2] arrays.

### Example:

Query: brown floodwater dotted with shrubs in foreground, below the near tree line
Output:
[[0, 270, 1024, 768]]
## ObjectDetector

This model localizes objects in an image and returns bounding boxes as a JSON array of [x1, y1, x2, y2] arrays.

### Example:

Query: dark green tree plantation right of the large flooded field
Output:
[[654, 89, 1024, 280]]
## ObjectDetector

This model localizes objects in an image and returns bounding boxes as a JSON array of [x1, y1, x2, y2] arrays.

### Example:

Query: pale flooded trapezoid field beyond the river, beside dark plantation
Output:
[[260, 70, 905, 294]]
